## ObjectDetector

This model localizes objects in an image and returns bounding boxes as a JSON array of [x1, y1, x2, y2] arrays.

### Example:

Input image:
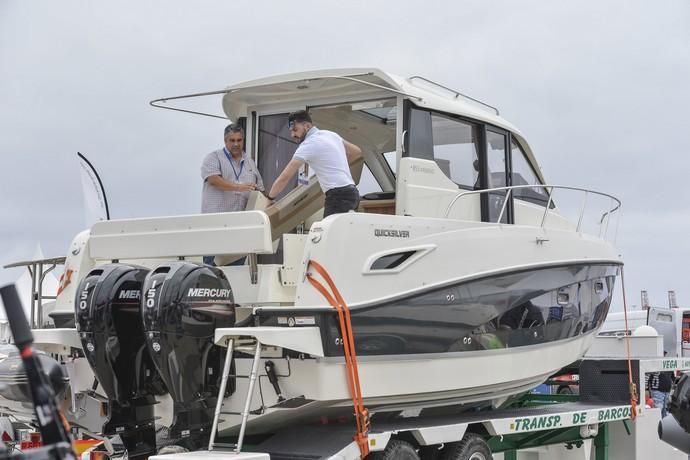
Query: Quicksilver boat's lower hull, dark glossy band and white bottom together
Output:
[[221, 263, 618, 433]]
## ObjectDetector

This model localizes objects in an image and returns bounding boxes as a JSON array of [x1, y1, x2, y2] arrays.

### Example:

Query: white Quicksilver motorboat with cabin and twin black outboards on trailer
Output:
[[6, 69, 622, 452]]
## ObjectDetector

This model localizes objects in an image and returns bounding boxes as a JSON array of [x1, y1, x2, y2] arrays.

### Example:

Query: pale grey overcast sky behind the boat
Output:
[[0, 0, 690, 308]]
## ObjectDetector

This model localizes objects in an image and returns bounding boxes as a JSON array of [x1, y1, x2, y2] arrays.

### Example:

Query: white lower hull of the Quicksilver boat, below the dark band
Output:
[[219, 331, 596, 435]]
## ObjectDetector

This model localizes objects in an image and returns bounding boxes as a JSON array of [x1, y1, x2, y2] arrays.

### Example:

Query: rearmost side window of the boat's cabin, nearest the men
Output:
[[409, 109, 479, 190]]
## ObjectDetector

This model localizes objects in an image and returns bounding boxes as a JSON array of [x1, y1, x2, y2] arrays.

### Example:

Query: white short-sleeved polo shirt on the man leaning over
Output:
[[293, 126, 355, 193]]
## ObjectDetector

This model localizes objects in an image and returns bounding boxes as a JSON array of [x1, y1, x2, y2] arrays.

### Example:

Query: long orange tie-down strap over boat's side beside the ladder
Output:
[[307, 260, 369, 458]]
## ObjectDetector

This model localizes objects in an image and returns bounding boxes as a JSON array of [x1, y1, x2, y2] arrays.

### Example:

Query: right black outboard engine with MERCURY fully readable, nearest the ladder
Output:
[[141, 262, 235, 449]]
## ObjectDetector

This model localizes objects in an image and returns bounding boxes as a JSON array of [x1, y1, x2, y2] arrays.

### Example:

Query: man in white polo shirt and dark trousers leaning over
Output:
[[268, 110, 362, 217]]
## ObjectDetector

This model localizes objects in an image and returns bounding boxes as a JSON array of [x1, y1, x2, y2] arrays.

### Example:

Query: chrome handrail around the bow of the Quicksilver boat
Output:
[[444, 184, 621, 236]]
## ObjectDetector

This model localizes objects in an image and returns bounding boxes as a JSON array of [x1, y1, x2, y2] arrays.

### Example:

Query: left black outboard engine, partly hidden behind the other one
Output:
[[75, 264, 165, 457]]
